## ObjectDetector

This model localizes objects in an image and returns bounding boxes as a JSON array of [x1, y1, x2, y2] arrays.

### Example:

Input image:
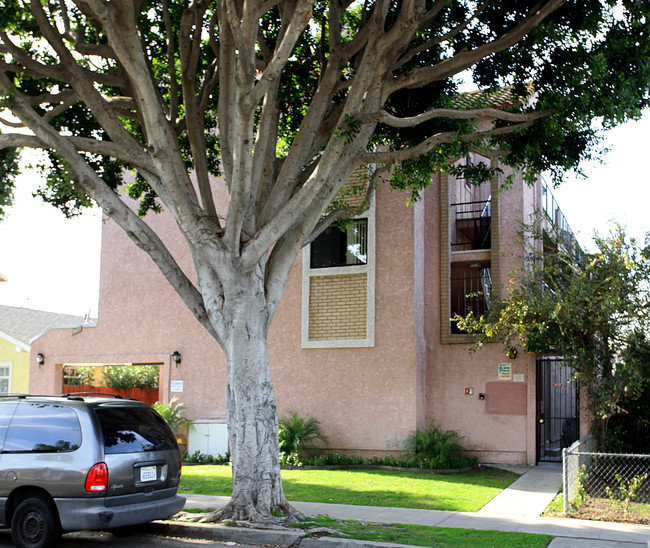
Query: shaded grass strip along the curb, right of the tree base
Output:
[[296, 517, 553, 548]]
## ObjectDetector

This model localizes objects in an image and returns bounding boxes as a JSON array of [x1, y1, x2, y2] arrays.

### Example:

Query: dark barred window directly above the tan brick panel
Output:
[[310, 219, 368, 268]]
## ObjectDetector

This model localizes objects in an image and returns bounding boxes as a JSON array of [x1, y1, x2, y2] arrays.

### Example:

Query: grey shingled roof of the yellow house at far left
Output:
[[0, 305, 85, 345]]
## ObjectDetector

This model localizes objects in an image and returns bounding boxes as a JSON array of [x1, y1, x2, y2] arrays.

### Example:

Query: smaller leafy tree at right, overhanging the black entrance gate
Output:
[[457, 224, 650, 449]]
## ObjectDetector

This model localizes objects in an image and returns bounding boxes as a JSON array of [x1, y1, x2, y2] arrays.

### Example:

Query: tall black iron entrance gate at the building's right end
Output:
[[537, 356, 580, 462]]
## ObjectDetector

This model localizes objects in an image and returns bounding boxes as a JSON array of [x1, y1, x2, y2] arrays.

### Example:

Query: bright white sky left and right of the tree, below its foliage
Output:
[[0, 113, 650, 317]]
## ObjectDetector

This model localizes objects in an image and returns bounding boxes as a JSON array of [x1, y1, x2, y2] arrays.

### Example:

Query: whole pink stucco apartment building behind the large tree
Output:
[[30, 159, 578, 464]]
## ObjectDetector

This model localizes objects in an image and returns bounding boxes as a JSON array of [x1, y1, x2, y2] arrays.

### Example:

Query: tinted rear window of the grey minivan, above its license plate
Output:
[[95, 406, 177, 454]]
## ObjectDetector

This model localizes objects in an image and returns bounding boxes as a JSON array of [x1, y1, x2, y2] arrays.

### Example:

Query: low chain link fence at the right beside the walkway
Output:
[[562, 436, 650, 523]]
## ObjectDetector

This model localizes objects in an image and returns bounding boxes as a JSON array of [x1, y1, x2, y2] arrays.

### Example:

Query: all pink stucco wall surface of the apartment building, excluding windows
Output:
[[30, 169, 568, 464]]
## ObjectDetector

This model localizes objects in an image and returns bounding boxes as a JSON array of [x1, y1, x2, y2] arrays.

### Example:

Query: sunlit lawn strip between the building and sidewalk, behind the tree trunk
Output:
[[180, 465, 518, 512]]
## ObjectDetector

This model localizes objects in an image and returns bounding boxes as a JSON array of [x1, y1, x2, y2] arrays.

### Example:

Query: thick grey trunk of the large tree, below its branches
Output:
[[205, 270, 295, 522]]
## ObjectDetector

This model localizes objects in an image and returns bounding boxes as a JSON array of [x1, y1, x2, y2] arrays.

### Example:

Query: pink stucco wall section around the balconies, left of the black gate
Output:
[[423, 169, 536, 464]]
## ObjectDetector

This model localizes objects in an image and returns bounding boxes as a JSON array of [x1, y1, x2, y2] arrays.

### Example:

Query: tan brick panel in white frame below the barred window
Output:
[[309, 274, 368, 341]]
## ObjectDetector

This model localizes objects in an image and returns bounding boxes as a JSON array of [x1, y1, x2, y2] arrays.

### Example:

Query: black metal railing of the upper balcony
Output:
[[450, 200, 492, 251]]
